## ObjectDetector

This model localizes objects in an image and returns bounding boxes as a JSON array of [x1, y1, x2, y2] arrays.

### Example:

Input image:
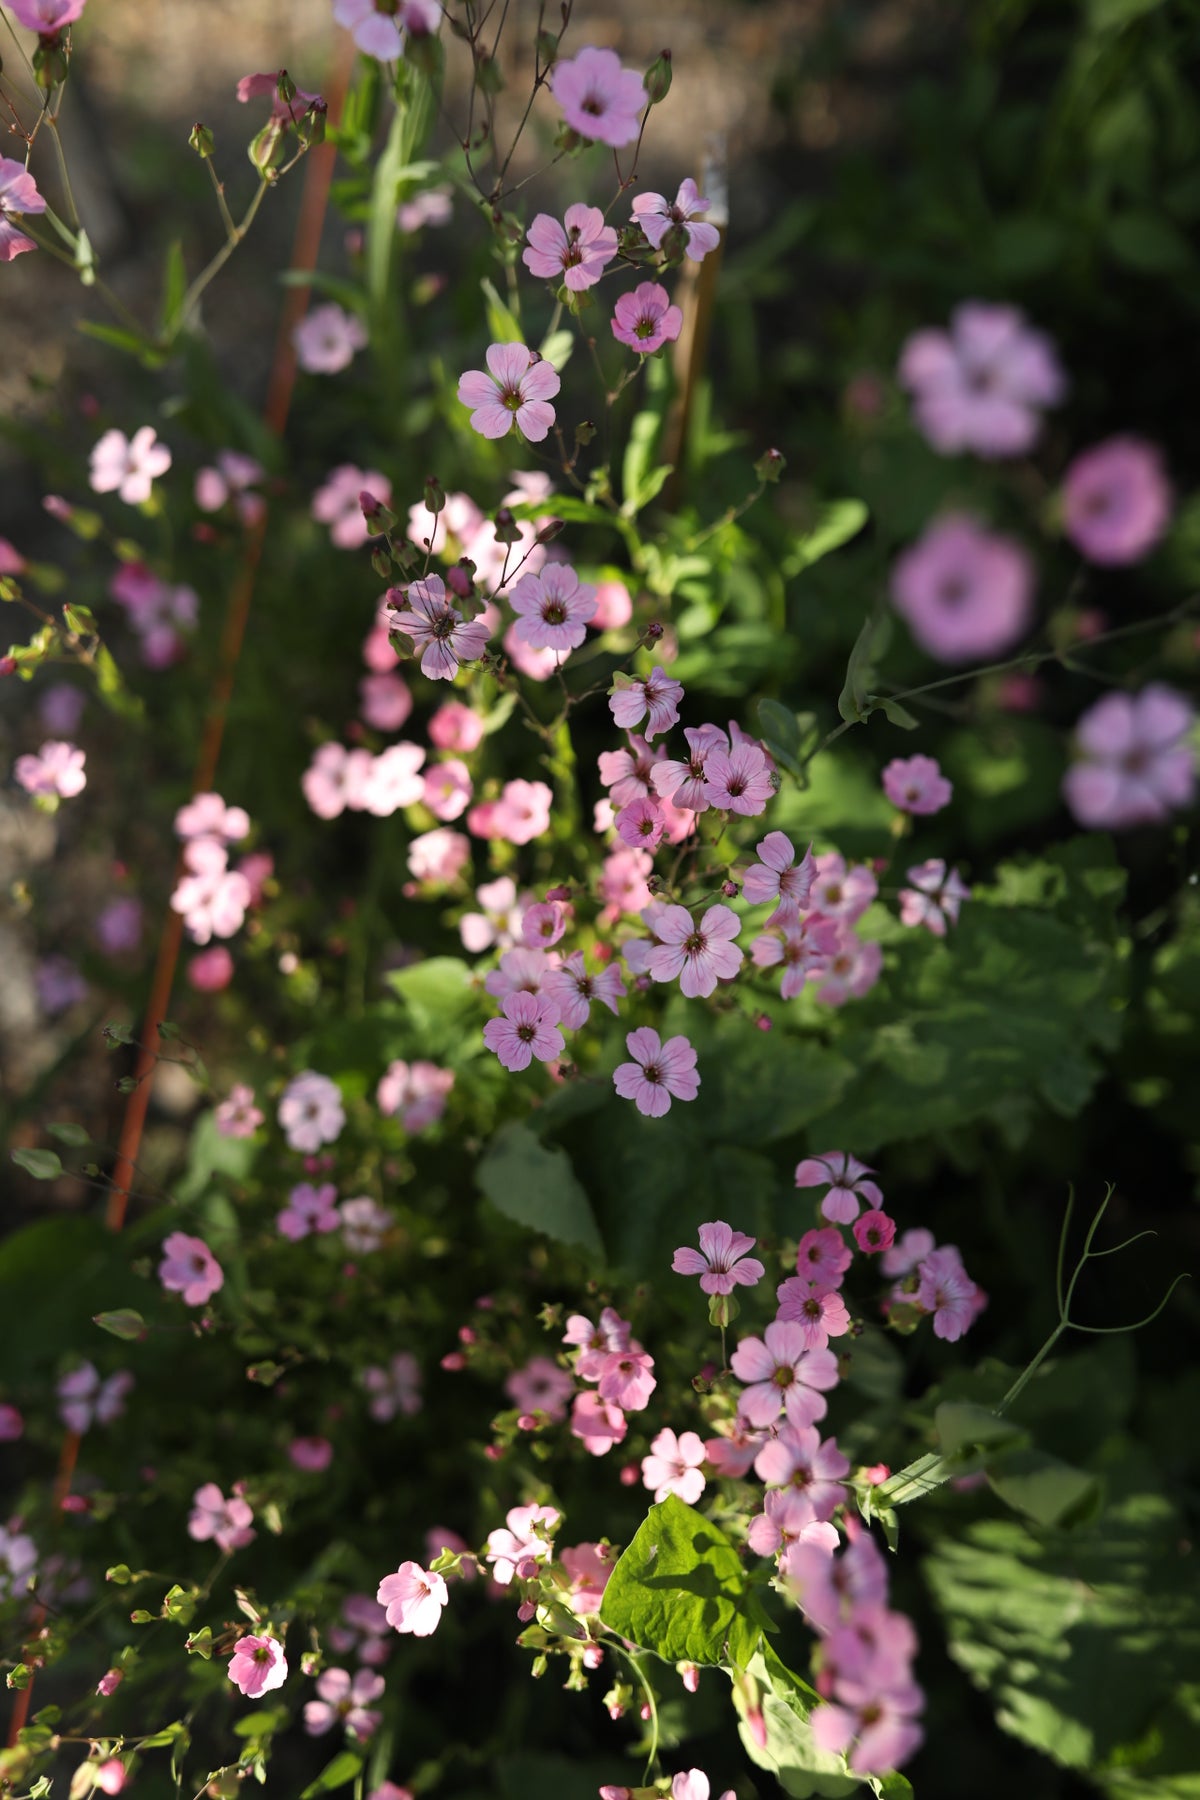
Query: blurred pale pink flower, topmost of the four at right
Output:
[[900, 301, 1067, 457]]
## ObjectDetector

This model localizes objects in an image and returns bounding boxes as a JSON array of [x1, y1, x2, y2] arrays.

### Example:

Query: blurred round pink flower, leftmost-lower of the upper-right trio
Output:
[[892, 513, 1034, 662]]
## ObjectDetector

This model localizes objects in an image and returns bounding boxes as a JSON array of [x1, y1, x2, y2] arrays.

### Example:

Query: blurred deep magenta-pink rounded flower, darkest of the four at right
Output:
[[1063, 437, 1171, 565]]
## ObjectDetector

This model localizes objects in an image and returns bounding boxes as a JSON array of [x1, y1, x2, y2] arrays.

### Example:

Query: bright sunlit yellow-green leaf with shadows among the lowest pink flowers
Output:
[[601, 1494, 765, 1669]]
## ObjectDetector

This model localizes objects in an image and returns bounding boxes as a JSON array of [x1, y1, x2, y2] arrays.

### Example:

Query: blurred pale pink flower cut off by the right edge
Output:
[[1063, 682, 1196, 832]]
